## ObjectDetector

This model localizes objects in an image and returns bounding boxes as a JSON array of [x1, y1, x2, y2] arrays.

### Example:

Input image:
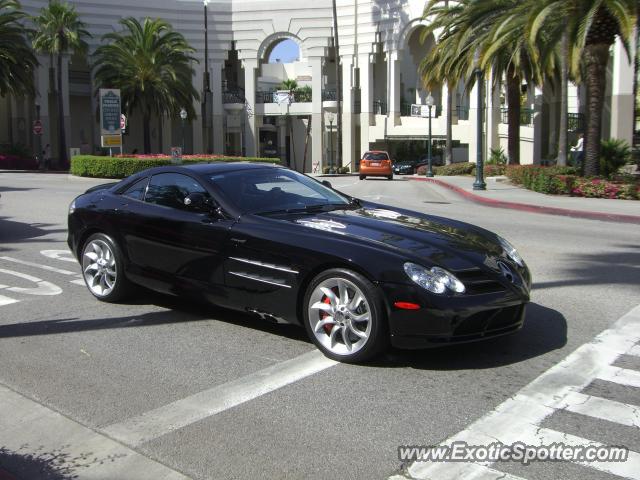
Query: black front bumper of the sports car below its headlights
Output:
[[381, 278, 529, 349]]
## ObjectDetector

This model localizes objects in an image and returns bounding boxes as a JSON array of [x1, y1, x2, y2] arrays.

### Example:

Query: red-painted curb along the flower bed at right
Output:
[[408, 178, 640, 225]]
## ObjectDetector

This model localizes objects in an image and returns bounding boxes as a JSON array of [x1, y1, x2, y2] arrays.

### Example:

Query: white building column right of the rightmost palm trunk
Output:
[[611, 33, 636, 145]]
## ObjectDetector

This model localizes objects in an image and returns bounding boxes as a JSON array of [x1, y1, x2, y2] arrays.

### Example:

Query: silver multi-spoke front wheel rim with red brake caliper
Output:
[[308, 278, 371, 355]]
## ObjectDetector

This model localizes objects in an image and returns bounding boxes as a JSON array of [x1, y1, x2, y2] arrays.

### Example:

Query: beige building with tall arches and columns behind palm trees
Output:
[[0, 0, 634, 171]]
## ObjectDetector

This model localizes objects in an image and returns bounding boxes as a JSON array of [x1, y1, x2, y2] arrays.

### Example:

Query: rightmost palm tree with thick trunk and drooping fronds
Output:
[[527, 0, 638, 176]]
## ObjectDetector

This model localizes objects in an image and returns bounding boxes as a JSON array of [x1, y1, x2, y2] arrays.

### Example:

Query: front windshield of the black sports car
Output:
[[210, 167, 353, 214]]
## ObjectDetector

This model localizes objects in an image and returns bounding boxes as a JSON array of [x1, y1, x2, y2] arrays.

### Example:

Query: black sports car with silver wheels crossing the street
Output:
[[68, 163, 531, 362]]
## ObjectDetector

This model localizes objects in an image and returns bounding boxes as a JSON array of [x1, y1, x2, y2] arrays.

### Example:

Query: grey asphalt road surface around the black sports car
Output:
[[0, 173, 640, 480]]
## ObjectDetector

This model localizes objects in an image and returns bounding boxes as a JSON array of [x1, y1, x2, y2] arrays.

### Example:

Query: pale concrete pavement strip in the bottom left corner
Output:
[[0, 385, 188, 480]]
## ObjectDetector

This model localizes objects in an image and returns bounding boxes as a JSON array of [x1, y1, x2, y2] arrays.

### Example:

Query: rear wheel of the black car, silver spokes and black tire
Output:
[[80, 233, 132, 303]]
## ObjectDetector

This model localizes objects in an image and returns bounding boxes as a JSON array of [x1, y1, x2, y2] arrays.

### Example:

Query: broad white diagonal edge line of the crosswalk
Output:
[[400, 305, 640, 480]]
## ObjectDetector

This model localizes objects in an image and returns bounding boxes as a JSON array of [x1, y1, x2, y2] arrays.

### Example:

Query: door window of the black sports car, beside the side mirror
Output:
[[144, 173, 209, 210]]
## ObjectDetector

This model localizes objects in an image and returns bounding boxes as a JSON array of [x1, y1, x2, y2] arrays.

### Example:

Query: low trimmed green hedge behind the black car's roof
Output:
[[70, 155, 280, 178]]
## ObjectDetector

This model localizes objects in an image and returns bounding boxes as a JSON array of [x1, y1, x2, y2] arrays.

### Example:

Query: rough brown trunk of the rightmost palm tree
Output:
[[582, 44, 609, 176]]
